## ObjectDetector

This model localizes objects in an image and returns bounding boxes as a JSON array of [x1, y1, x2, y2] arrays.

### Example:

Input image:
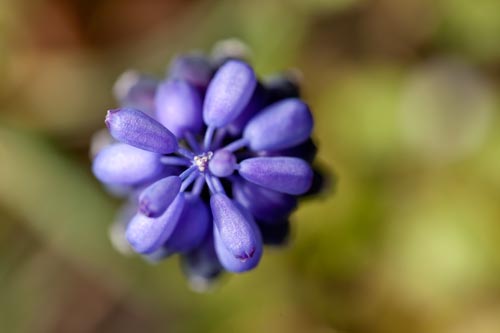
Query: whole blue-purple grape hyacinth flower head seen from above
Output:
[[93, 42, 318, 285]]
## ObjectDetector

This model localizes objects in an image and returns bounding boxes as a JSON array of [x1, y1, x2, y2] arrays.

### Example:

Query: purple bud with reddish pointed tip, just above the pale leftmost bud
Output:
[[105, 108, 178, 154]]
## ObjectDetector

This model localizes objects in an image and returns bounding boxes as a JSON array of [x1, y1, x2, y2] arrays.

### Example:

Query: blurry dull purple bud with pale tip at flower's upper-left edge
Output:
[[114, 70, 158, 115]]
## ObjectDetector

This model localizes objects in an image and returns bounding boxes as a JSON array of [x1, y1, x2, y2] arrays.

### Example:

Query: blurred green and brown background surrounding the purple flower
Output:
[[0, 0, 500, 333]]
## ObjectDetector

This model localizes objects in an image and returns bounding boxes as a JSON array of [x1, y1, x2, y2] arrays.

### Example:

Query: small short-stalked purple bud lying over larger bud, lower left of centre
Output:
[[139, 176, 182, 217]]
